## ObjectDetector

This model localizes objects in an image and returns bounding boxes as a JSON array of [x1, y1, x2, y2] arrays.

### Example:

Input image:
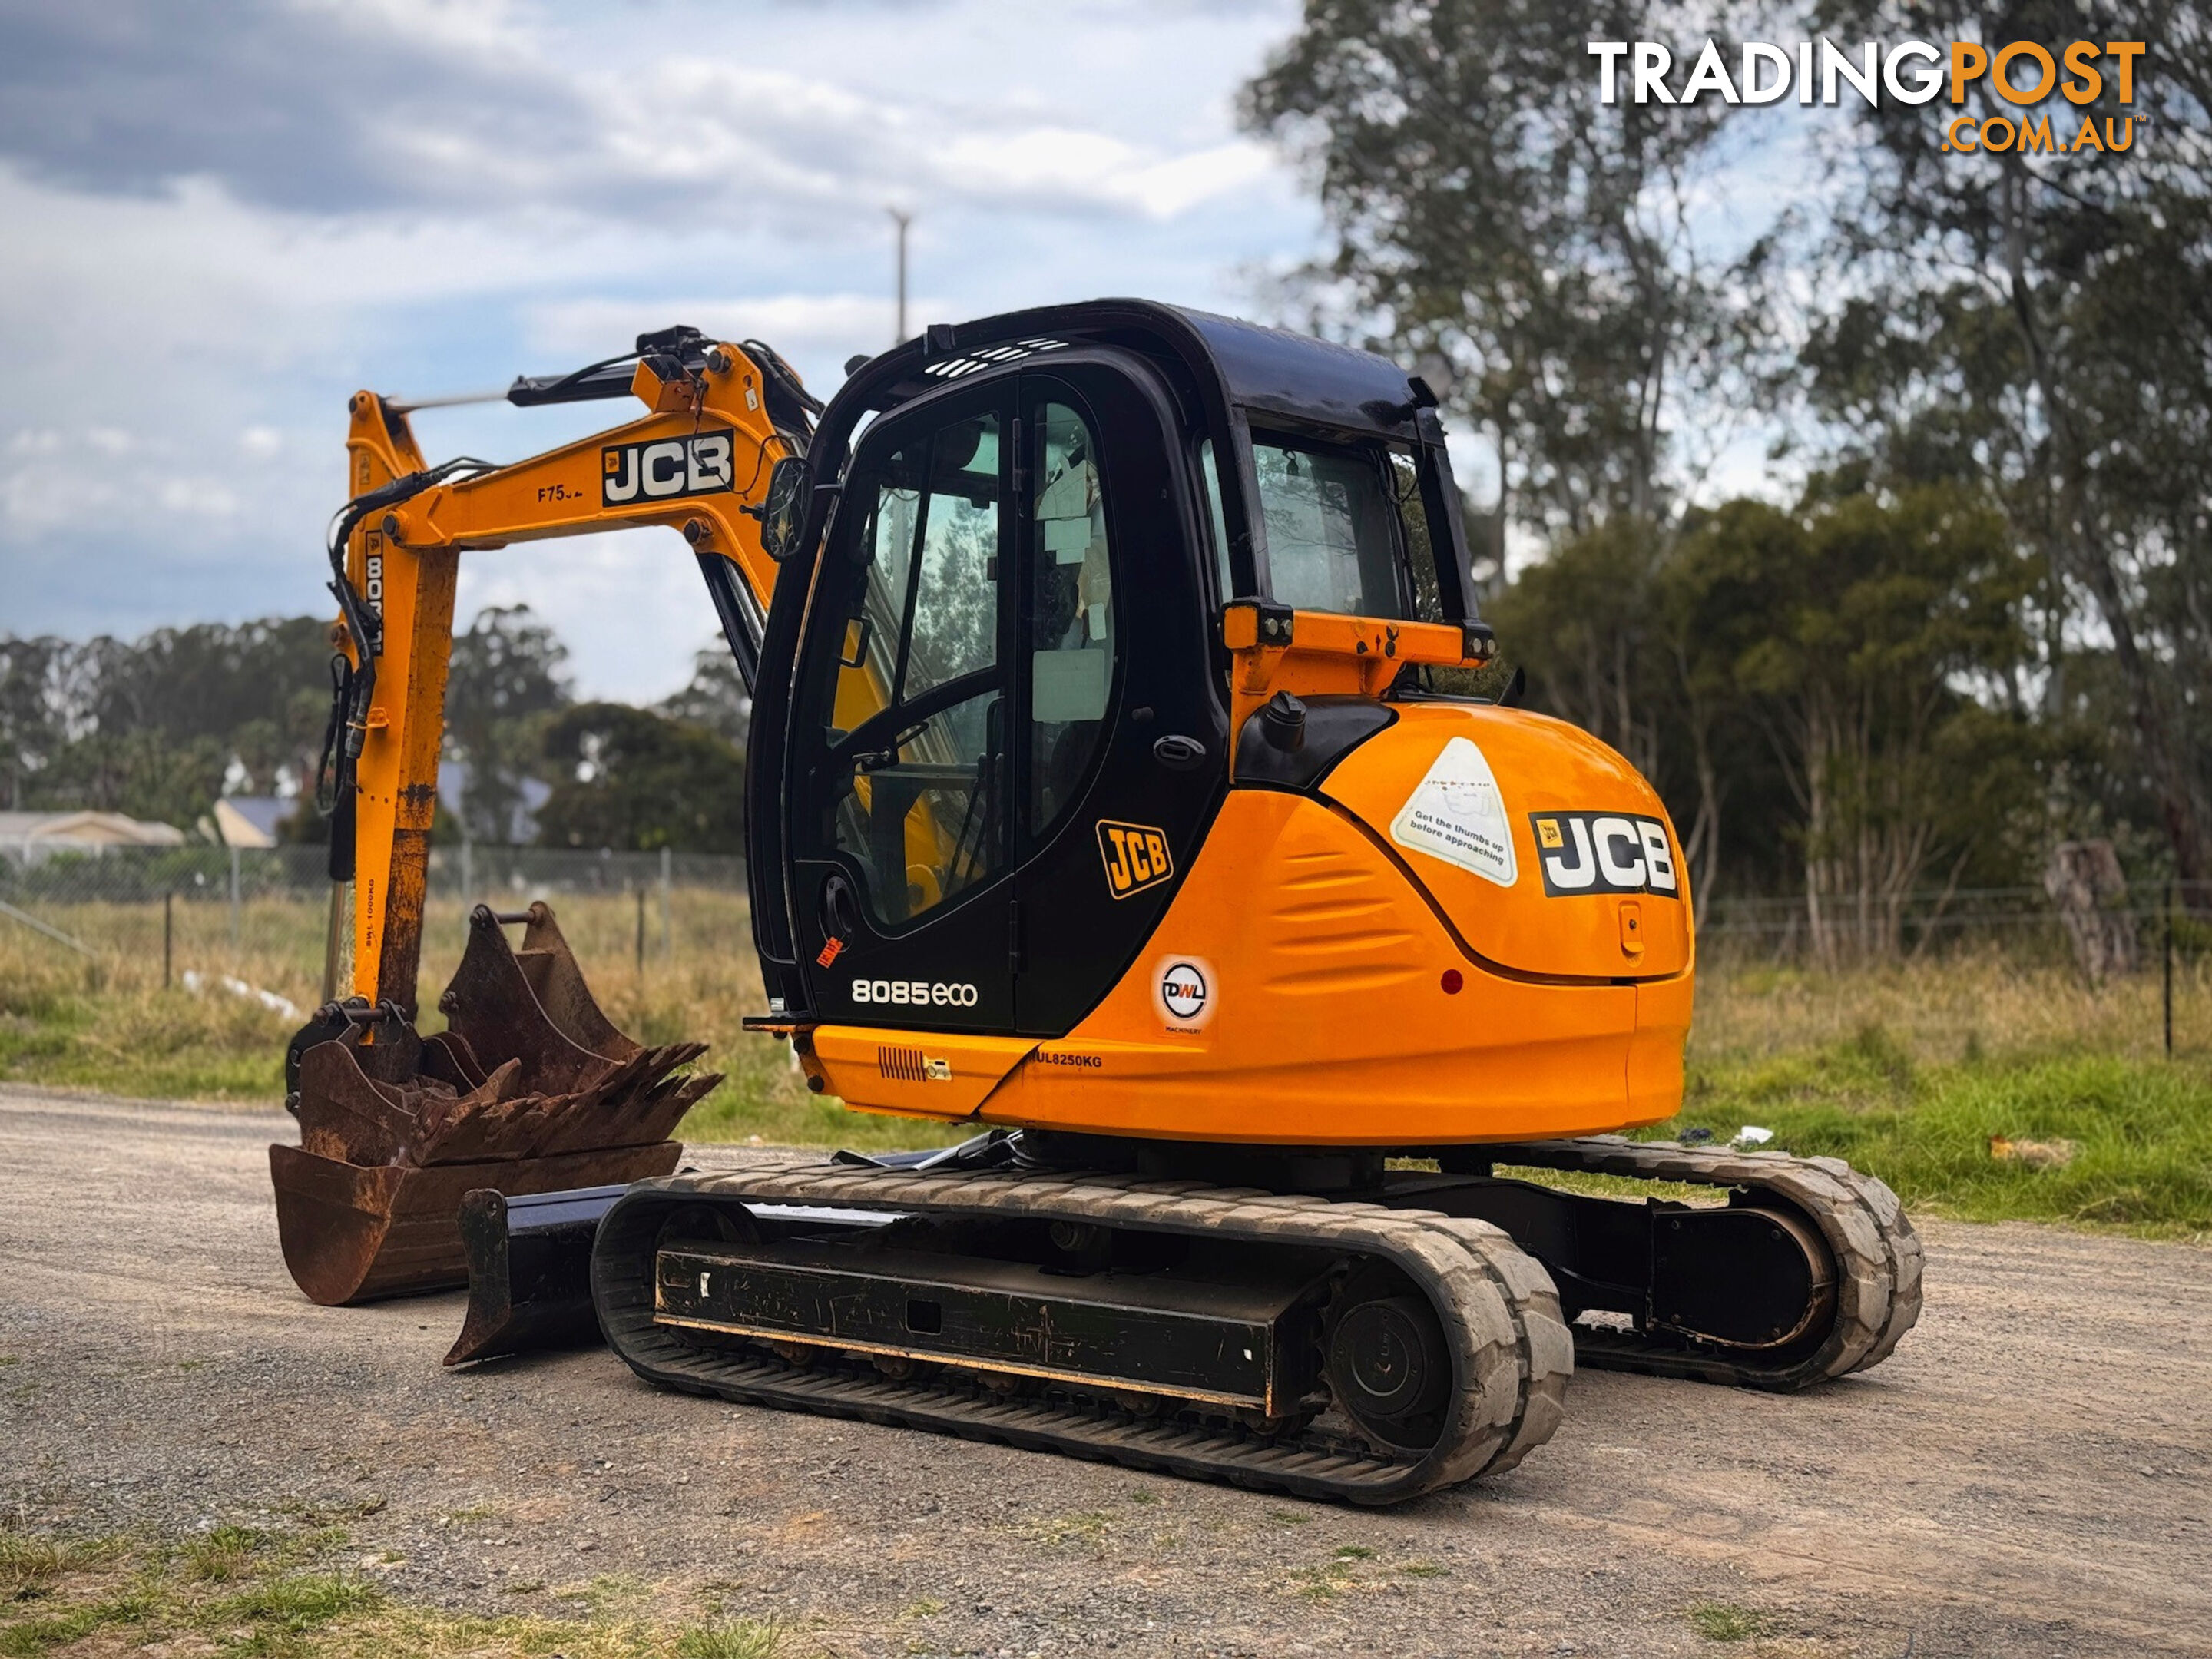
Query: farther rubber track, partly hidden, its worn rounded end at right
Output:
[[1482, 1134, 1920, 1392]]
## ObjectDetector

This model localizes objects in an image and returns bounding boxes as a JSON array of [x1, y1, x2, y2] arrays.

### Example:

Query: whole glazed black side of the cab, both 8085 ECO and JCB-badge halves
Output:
[[759, 318, 1256, 1035]]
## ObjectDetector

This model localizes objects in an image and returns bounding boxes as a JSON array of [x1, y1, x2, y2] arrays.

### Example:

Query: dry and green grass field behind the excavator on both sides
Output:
[[0, 916, 2212, 1239]]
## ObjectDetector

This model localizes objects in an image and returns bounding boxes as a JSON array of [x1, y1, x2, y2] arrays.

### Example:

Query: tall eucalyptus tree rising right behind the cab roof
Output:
[[1243, 0, 1763, 546]]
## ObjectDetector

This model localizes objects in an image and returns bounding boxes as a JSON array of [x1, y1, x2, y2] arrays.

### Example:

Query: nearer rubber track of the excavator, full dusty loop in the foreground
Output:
[[593, 1166, 1575, 1504]]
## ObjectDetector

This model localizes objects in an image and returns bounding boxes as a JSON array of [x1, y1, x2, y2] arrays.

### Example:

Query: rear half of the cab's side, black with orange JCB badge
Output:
[[1008, 369, 1227, 1038]]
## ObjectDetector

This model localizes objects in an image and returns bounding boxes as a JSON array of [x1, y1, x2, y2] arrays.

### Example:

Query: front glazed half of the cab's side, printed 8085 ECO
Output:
[[785, 380, 1018, 1031]]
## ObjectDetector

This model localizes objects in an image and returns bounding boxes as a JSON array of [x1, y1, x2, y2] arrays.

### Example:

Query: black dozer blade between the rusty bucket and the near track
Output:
[[445, 1186, 631, 1365]]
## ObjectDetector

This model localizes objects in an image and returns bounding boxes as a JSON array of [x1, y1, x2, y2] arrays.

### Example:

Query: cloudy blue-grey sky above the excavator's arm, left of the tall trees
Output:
[[0, 0, 1318, 699]]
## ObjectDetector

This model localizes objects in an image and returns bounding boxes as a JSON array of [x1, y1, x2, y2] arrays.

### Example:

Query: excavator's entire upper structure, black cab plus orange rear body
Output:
[[747, 301, 1690, 1146]]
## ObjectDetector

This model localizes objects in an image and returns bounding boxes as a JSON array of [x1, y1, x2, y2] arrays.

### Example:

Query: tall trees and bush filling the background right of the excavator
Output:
[[1243, 0, 2212, 942]]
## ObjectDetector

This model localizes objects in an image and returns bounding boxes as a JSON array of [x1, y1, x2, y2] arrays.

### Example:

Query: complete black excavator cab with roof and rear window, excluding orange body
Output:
[[752, 303, 1486, 1038]]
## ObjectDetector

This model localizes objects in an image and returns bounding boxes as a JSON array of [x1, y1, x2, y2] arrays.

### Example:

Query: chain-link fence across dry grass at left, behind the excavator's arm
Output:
[[0, 845, 752, 1006]]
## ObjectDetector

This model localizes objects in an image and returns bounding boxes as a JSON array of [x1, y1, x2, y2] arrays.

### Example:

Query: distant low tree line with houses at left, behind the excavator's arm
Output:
[[0, 606, 752, 852]]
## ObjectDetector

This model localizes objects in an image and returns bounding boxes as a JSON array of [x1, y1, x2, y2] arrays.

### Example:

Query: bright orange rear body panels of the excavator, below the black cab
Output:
[[816, 704, 1692, 1146]]
